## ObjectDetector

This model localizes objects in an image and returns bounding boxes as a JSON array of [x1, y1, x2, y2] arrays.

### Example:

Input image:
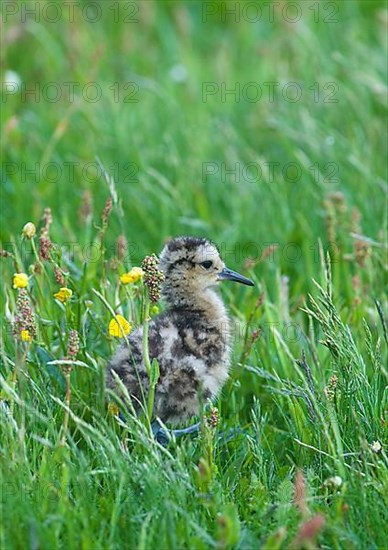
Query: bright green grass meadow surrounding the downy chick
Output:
[[0, 0, 388, 550]]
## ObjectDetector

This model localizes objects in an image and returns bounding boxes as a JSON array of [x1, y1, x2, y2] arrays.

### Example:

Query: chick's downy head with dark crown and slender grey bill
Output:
[[159, 237, 253, 306]]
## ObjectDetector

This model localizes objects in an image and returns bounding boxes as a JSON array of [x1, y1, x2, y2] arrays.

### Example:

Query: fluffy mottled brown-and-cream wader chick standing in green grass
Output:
[[107, 237, 253, 424]]
